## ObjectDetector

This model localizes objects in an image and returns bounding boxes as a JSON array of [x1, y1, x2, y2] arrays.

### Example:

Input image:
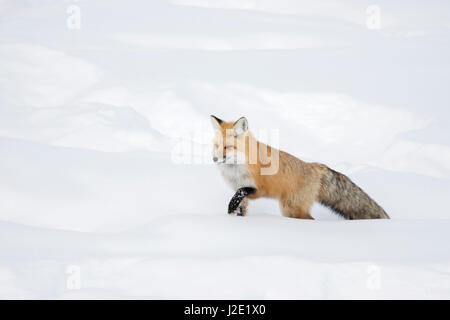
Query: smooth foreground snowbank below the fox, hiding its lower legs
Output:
[[0, 214, 450, 299]]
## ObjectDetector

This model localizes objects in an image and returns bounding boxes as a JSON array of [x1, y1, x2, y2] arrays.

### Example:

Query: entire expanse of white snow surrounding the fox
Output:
[[0, 0, 450, 299]]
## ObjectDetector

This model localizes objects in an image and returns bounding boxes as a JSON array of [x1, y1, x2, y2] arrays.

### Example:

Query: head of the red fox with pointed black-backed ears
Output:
[[211, 115, 249, 164]]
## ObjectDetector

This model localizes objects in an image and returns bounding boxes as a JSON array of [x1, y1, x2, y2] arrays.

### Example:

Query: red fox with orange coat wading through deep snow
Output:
[[211, 116, 389, 219]]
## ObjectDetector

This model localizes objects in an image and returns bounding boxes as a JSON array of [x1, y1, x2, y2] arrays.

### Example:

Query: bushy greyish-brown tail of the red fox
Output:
[[318, 168, 389, 220]]
